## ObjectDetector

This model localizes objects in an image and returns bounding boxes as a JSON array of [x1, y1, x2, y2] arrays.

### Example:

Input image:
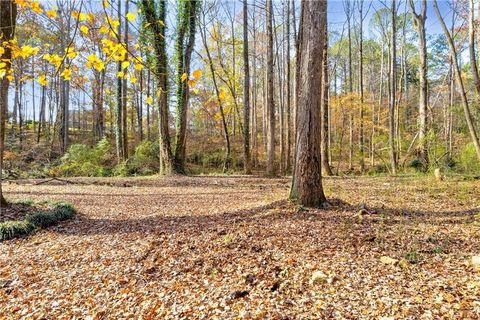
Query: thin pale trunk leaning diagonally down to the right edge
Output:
[[433, 0, 480, 161]]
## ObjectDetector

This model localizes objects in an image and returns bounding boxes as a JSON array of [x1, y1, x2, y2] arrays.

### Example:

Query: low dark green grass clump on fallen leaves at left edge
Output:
[[0, 201, 75, 241]]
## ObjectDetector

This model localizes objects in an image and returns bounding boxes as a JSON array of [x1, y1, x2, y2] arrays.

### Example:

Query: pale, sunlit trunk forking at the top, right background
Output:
[[409, 0, 428, 169]]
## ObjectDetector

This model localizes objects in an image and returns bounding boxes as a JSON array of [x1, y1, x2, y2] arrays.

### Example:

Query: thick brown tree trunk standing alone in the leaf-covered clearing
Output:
[[290, 0, 326, 207]]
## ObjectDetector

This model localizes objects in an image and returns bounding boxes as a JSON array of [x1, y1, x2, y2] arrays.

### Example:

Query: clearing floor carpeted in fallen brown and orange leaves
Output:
[[0, 176, 480, 319]]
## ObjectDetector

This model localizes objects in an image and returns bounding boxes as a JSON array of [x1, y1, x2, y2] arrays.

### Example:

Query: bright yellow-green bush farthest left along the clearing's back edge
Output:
[[58, 139, 112, 177]]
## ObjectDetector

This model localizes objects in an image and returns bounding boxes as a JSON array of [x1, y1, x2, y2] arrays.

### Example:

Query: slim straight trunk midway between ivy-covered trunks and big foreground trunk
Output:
[[244, 0, 252, 174]]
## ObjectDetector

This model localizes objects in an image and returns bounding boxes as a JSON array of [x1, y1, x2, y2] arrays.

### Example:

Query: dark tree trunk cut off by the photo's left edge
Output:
[[0, 0, 17, 207]]
